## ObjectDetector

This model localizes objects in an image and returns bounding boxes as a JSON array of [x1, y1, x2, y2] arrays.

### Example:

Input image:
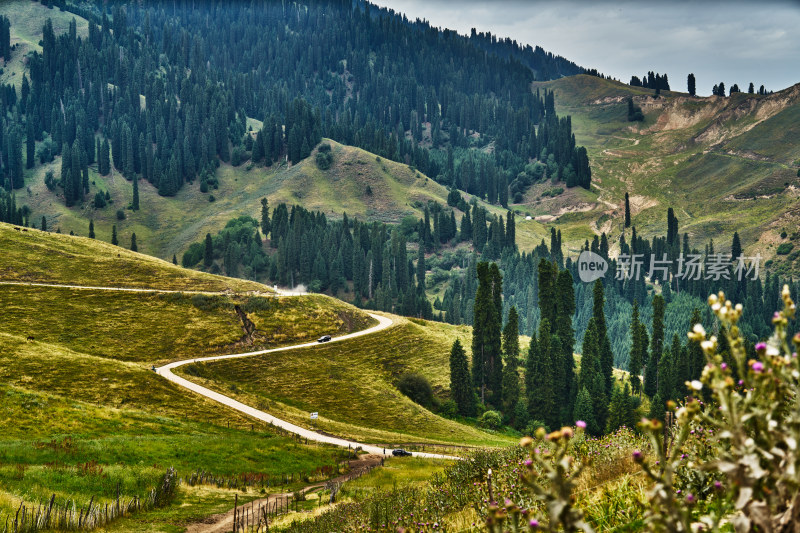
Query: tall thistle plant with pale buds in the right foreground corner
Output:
[[635, 286, 800, 532]]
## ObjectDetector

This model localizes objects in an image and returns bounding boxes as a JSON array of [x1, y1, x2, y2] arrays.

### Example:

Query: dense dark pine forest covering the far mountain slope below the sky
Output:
[[0, 2, 591, 217]]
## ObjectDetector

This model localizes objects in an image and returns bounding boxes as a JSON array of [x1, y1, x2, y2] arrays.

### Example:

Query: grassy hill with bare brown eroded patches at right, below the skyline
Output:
[[534, 75, 800, 268]]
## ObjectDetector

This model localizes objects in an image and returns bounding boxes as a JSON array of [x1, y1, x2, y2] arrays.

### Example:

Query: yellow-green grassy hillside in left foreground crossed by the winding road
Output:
[[0, 224, 509, 530]]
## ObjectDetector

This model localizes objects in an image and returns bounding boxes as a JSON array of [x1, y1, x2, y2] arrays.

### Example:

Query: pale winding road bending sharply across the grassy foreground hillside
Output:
[[156, 313, 459, 460]]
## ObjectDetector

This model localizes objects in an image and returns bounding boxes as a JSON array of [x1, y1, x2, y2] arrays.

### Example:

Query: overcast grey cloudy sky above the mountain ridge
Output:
[[373, 0, 800, 95]]
